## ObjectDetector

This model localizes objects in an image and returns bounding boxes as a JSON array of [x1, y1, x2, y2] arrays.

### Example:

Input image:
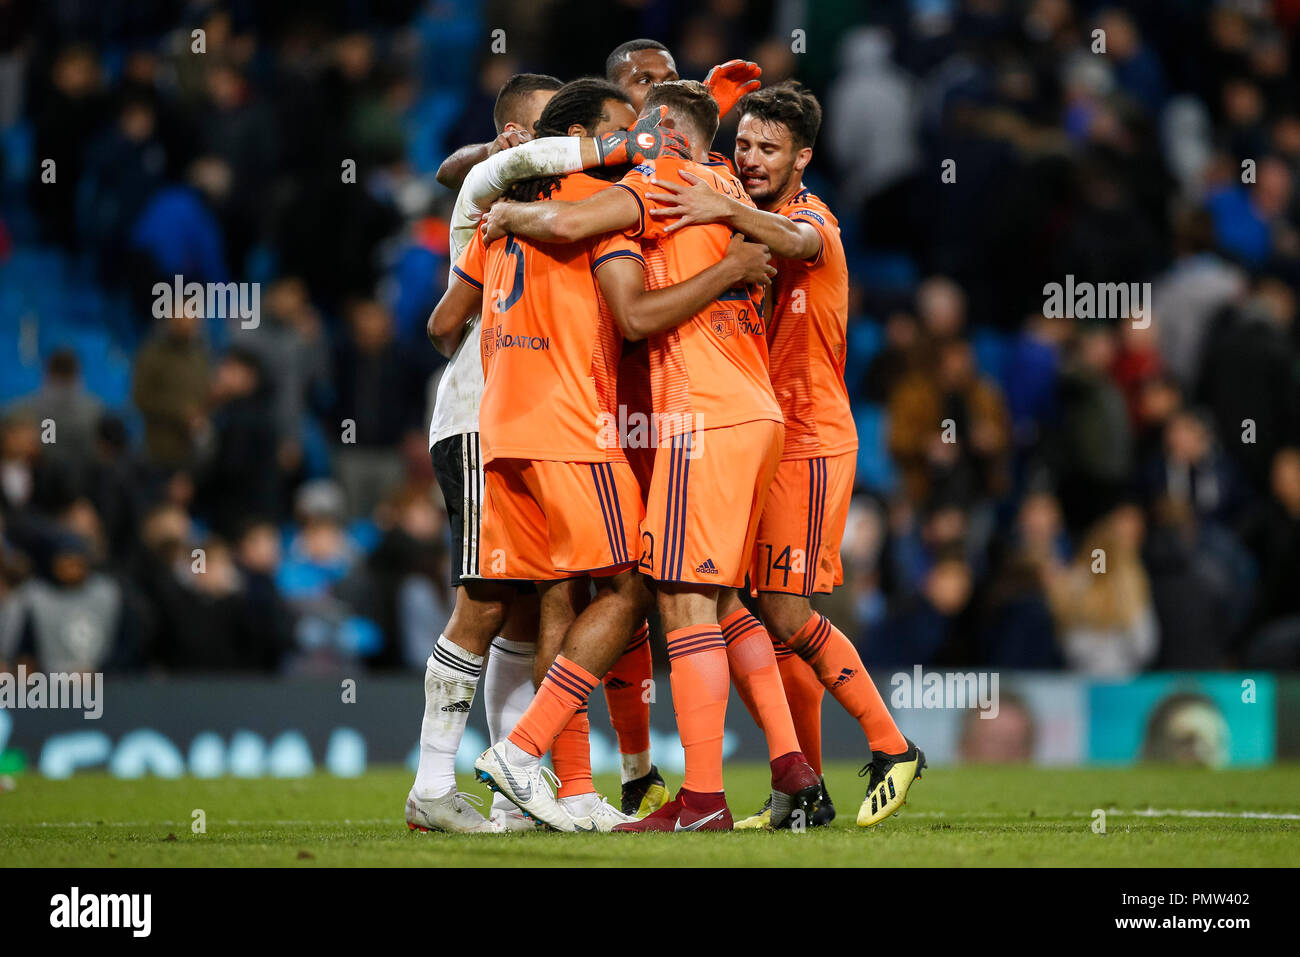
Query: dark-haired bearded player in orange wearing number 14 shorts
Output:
[[649, 83, 926, 827]]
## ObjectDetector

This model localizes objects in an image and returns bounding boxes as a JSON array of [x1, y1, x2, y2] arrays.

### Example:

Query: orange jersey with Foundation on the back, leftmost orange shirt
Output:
[[455, 173, 641, 462]]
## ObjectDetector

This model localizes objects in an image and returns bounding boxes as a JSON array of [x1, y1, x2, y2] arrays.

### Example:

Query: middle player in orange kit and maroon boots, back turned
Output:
[[485, 81, 820, 831]]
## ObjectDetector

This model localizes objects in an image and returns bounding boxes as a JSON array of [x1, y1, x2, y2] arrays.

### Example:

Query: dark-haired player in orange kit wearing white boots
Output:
[[433, 79, 767, 831]]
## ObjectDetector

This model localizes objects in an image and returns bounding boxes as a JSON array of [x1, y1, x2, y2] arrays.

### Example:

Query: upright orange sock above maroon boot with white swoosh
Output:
[[668, 624, 731, 794]]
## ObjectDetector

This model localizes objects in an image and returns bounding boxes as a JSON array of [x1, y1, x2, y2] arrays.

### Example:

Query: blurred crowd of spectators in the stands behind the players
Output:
[[0, 0, 1300, 675]]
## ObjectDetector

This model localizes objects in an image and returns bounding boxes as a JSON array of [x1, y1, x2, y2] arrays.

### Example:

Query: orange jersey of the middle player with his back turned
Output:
[[618, 156, 781, 445]]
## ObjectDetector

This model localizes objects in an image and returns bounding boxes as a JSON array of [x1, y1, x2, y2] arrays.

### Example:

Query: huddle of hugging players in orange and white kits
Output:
[[406, 40, 926, 833]]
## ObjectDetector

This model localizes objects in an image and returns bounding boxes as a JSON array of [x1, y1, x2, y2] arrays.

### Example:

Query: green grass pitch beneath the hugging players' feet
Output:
[[0, 765, 1300, 867]]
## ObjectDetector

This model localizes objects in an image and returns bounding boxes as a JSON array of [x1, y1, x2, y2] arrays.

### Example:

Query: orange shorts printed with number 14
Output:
[[749, 451, 858, 596]]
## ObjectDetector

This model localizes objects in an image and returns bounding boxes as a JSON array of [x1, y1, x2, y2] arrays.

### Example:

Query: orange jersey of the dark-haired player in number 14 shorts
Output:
[[767, 189, 858, 460]]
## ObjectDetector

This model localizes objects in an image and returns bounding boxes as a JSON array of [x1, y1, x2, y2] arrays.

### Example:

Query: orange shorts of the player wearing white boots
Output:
[[478, 459, 644, 581]]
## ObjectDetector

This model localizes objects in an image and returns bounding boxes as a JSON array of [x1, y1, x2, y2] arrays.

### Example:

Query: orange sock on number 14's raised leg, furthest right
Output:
[[788, 611, 907, 754]]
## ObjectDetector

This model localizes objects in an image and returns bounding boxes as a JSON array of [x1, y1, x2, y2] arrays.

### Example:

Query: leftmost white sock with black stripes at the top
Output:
[[415, 635, 484, 797]]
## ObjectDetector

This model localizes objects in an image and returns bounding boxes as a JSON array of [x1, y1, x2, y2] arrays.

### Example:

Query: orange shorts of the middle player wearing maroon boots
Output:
[[641, 420, 785, 588]]
